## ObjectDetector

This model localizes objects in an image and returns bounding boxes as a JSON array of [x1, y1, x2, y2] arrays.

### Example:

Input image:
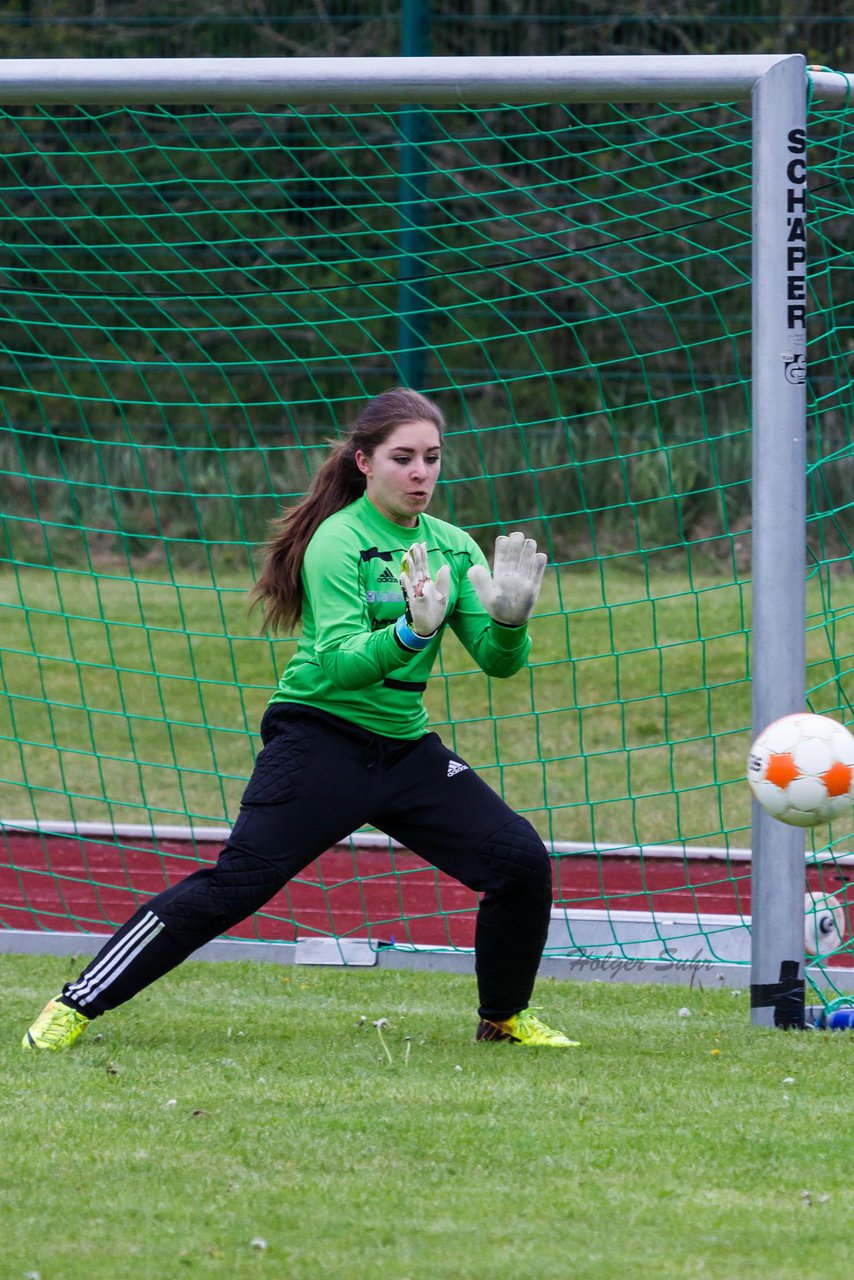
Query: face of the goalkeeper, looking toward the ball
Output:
[[356, 420, 442, 529]]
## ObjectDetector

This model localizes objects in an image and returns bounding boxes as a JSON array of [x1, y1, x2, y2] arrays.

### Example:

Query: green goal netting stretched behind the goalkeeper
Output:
[[0, 85, 854, 978]]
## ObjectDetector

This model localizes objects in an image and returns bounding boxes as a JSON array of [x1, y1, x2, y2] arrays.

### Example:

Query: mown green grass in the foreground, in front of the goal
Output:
[[0, 956, 851, 1280]]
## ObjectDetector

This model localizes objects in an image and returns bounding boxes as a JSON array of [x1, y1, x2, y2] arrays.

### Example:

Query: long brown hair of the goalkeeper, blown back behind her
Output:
[[250, 387, 444, 631]]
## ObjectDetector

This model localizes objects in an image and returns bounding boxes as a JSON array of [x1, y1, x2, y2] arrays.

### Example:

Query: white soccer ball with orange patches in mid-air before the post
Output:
[[748, 712, 854, 827]]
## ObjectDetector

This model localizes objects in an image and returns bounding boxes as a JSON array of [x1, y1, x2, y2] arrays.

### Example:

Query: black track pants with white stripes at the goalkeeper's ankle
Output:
[[63, 704, 552, 1019]]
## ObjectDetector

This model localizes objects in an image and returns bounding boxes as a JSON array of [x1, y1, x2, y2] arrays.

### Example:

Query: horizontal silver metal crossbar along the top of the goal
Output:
[[0, 54, 850, 106]]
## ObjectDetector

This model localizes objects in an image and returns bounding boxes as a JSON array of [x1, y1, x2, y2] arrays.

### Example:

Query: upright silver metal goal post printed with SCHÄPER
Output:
[[750, 58, 807, 1027]]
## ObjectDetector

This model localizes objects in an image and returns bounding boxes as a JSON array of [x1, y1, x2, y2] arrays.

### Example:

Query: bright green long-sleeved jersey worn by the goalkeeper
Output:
[[271, 495, 530, 739]]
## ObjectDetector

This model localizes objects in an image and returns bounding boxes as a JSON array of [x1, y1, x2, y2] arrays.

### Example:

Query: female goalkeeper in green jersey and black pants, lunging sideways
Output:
[[23, 388, 575, 1050]]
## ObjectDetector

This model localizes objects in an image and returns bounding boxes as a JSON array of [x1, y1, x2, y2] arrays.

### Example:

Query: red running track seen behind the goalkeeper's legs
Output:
[[0, 832, 850, 947]]
